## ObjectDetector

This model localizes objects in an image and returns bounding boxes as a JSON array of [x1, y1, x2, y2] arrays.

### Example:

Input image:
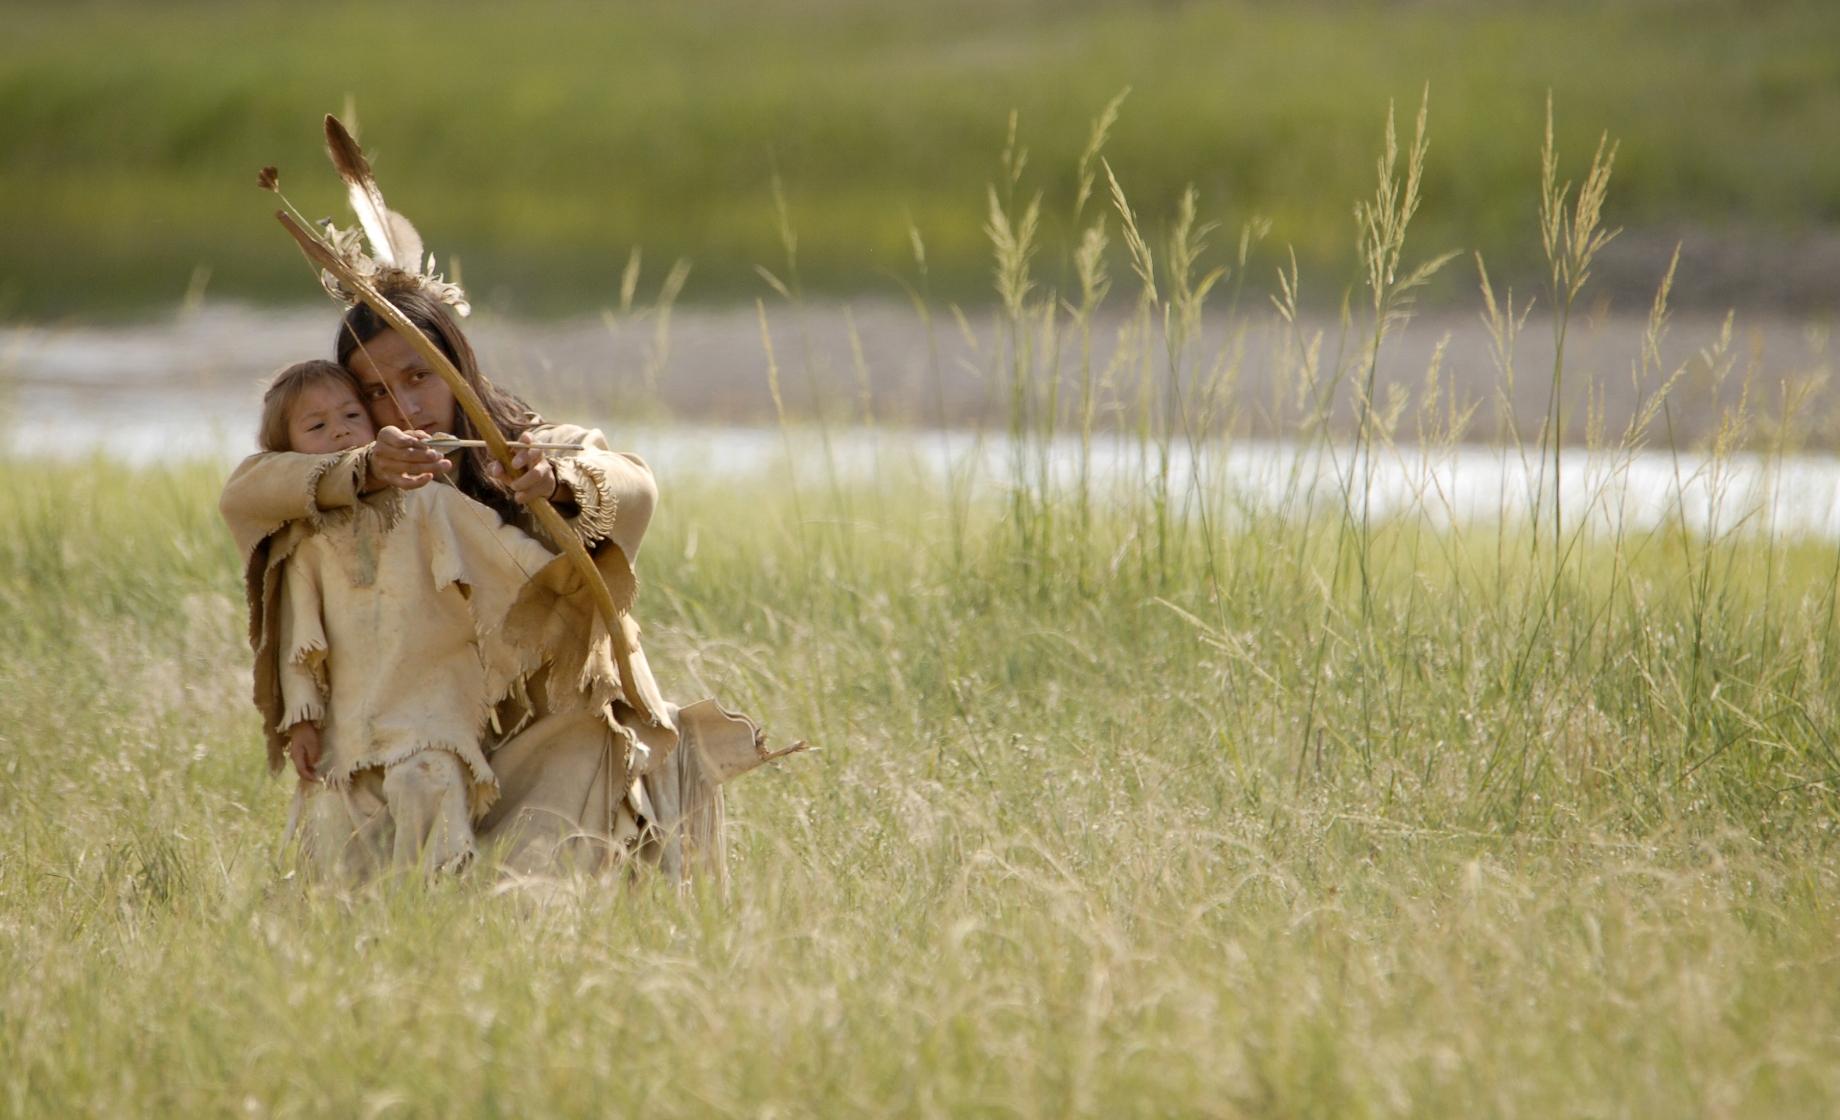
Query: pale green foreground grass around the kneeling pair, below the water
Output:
[[0, 443, 1840, 1116]]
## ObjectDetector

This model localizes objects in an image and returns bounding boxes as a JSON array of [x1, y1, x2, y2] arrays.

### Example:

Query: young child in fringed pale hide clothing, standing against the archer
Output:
[[259, 360, 552, 877]]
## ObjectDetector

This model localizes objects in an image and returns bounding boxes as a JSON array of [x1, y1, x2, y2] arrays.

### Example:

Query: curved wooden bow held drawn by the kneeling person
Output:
[[274, 210, 664, 726]]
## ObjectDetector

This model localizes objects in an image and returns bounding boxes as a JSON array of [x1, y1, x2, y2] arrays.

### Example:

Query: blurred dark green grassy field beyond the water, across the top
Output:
[[0, 0, 1840, 316]]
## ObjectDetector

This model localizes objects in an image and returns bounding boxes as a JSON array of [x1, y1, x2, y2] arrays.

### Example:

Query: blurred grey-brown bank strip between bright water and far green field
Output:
[[0, 296, 1840, 449]]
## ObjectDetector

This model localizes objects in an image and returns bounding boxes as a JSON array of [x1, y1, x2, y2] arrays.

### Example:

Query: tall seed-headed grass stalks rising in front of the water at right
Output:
[[897, 97, 1831, 828]]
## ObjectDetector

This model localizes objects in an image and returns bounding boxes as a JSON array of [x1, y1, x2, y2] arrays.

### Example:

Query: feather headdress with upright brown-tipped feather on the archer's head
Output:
[[320, 114, 473, 314]]
